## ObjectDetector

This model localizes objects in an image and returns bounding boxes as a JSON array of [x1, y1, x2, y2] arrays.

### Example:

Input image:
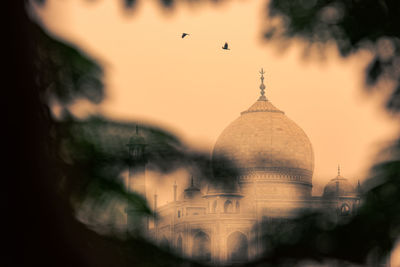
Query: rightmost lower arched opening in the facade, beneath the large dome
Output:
[[227, 232, 248, 262]]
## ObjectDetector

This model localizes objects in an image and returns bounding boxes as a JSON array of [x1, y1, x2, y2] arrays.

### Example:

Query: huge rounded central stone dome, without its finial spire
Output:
[[212, 95, 314, 185]]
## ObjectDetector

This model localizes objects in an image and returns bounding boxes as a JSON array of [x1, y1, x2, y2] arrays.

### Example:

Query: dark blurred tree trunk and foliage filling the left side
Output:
[[9, 1, 214, 266]]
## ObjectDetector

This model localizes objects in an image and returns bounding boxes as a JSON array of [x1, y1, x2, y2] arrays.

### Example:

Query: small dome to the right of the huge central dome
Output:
[[323, 173, 357, 198]]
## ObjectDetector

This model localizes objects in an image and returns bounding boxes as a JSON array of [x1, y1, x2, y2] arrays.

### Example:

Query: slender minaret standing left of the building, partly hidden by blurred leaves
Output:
[[126, 125, 148, 234]]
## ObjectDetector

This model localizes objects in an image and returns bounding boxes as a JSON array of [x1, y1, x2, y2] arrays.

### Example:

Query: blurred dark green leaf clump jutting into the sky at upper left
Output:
[[32, 25, 104, 105]]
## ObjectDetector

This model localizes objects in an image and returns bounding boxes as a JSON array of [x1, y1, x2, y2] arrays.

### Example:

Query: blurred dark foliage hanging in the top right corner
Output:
[[264, 0, 400, 113]]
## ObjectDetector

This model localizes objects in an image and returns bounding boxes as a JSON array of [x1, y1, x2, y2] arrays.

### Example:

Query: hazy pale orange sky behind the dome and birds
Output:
[[36, 0, 395, 199]]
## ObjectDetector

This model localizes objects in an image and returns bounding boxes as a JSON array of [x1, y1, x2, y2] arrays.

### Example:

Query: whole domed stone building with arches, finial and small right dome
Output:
[[128, 71, 360, 264]]
